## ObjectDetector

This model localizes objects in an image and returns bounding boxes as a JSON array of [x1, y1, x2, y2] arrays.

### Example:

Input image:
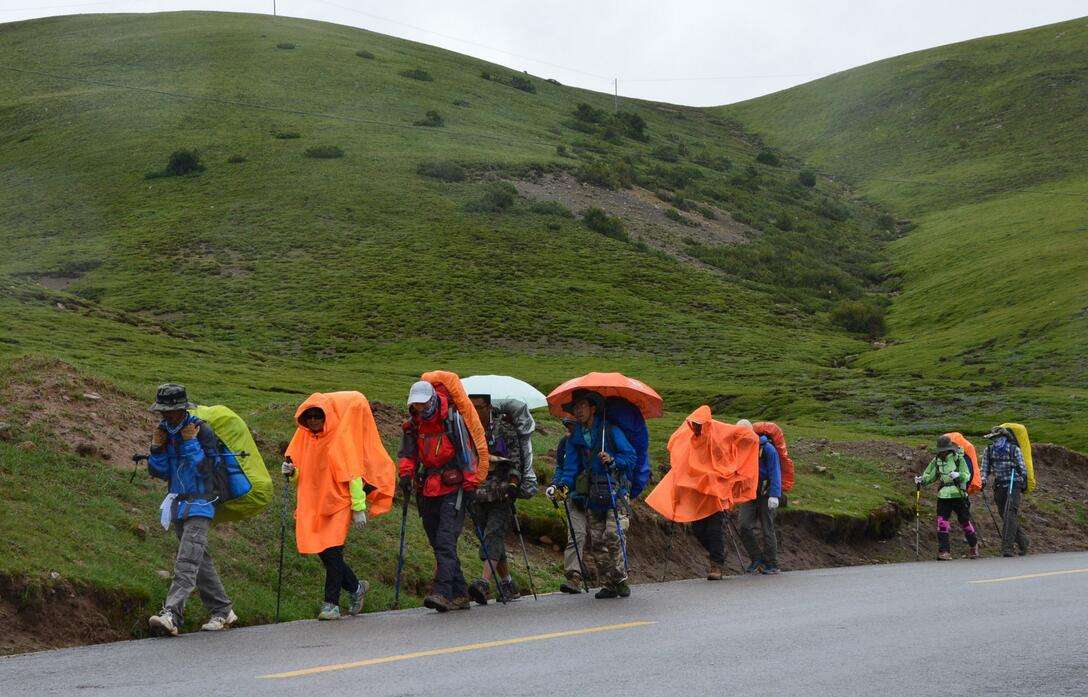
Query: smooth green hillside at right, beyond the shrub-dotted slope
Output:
[[721, 20, 1088, 448]]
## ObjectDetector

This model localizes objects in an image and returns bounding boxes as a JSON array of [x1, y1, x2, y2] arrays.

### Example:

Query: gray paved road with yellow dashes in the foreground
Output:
[[0, 552, 1088, 697]]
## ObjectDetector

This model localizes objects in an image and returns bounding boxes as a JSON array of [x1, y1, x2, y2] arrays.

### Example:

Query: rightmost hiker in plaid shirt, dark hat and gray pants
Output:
[[981, 426, 1029, 557]]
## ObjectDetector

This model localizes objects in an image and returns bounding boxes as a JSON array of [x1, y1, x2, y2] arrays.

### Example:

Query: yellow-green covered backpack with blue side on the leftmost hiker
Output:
[[189, 406, 272, 523]]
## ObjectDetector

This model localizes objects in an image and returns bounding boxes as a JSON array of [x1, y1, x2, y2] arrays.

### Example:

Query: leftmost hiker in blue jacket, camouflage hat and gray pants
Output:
[[147, 383, 238, 636]]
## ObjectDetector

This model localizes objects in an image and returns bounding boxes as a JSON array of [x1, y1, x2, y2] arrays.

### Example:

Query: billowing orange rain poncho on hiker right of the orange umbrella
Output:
[[646, 404, 759, 523]]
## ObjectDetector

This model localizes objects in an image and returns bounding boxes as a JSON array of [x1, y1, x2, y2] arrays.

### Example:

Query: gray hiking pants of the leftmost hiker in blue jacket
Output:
[[163, 518, 232, 622]]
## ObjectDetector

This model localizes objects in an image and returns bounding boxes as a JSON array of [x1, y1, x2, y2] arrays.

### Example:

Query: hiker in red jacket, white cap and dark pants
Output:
[[397, 381, 477, 612]]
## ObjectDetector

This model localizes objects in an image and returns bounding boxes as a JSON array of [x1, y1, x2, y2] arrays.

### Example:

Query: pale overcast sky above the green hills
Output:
[[0, 0, 1088, 105]]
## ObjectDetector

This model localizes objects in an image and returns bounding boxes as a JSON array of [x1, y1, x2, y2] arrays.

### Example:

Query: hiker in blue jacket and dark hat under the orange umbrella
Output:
[[546, 390, 638, 599]]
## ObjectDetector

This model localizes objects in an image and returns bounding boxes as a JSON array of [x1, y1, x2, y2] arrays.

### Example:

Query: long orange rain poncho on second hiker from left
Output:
[[286, 391, 396, 555]]
